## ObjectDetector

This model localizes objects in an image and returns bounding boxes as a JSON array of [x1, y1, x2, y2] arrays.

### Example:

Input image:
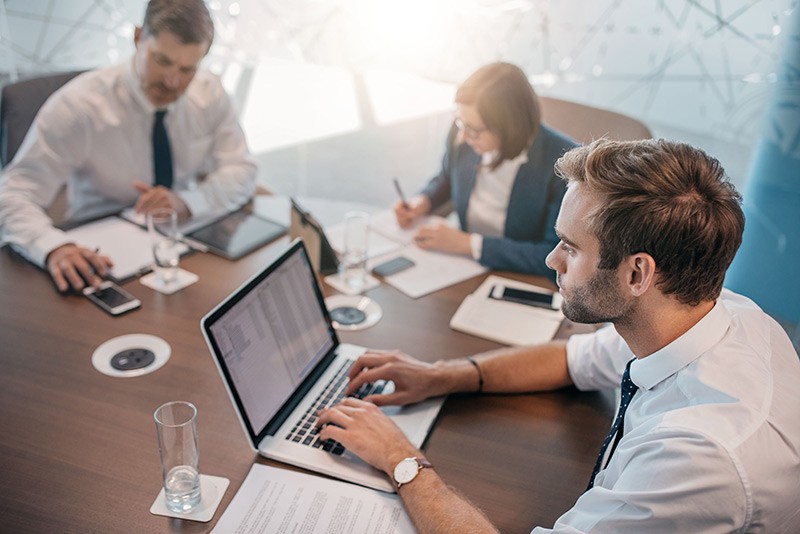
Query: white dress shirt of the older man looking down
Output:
[[0, 61, 256, 266]]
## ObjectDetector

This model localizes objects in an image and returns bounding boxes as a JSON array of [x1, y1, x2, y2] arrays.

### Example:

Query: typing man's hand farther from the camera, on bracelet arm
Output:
[[345, 350, 448, 406]]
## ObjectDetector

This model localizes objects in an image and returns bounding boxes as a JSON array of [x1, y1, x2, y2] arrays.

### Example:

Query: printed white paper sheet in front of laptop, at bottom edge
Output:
[[212, 464, 416, 534]]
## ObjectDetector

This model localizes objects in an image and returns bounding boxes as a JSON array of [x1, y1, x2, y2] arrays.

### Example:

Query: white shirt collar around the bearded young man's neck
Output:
[[631, 299, 731, 390]]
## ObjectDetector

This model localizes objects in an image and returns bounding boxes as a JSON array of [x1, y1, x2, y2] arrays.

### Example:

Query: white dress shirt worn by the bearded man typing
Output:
[[533, 290, 800, 534]]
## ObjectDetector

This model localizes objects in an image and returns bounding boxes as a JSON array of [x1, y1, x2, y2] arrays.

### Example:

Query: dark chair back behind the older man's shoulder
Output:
[[0, 71, 83, 167]]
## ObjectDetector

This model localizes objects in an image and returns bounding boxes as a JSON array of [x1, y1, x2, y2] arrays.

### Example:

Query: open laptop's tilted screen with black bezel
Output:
[[203, 240, 338, 441]]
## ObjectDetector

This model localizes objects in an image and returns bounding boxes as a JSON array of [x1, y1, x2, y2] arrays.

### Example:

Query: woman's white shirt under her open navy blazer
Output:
[[467, 149, 528, 260]]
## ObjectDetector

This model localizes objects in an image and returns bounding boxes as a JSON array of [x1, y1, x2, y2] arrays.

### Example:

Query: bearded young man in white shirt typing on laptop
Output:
[[320, 140, 800, 533]]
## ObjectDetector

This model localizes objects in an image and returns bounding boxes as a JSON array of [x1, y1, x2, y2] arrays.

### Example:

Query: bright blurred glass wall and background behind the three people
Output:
[[0, 0, 800, 343]]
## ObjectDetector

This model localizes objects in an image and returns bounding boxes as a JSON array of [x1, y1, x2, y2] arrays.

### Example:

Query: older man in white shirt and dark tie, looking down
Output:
[[0, 0, 256, 291]]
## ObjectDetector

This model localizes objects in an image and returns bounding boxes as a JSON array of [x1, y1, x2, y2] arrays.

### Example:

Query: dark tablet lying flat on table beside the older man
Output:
[[187, 210, 287, 260]]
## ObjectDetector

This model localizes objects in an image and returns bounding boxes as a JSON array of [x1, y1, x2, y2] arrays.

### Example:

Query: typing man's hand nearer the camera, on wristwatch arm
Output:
[[317, 397, 421, 473]]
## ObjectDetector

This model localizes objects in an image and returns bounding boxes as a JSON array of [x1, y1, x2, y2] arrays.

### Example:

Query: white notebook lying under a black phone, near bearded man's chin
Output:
[[450, 275, 564, 345]]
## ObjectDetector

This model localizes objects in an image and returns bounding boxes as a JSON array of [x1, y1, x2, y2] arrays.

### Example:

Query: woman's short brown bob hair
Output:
[[456, 63, 541, 168]]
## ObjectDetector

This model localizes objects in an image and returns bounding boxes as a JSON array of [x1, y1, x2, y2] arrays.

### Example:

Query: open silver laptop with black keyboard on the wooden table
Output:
[[201, 239, 443, 492]]
